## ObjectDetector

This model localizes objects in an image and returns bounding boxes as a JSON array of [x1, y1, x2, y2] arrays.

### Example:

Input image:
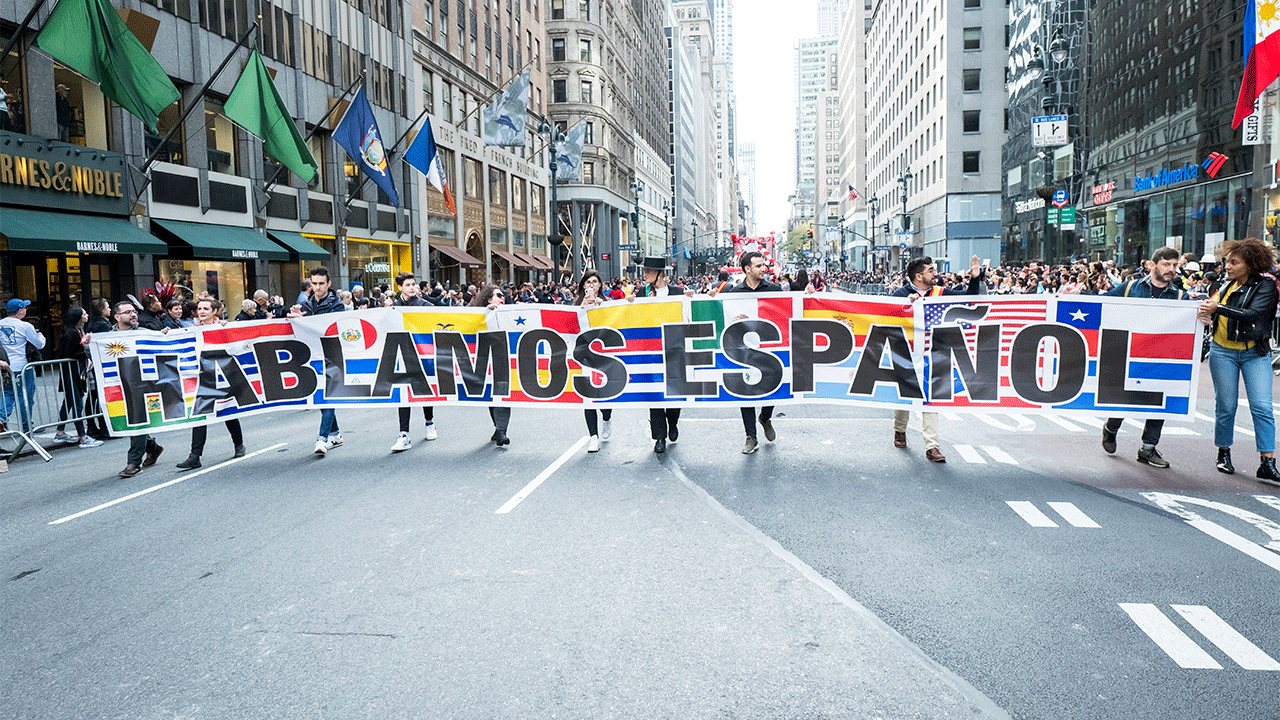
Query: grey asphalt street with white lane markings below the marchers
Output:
[[0, 372, 1280, 720]]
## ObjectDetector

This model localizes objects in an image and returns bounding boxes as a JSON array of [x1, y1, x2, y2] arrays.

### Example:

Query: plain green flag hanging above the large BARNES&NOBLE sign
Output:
[[36, 0, 179, 132]]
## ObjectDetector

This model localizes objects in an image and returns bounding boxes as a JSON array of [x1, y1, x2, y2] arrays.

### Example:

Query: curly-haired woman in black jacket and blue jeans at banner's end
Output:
[[1199, 237, 1280, 486]]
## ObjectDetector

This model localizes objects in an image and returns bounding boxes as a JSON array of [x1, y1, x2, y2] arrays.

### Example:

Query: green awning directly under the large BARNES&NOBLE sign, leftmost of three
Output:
[[0, 208, 169, 255]]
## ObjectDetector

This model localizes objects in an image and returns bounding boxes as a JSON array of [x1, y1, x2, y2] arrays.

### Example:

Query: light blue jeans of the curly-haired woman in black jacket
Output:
[[1208, 342, 1276, 452]]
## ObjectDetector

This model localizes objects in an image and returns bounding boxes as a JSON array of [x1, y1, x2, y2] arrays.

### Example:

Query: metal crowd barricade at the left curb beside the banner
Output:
[[0, 359, 102, 462]]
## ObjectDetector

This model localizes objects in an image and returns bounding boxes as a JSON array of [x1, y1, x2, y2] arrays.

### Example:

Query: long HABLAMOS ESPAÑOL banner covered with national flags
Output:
[[91, 293, 1202, 434]]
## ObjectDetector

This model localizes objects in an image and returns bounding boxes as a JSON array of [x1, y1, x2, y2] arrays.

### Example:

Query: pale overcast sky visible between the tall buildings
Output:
[[733, 0, 818, 234]]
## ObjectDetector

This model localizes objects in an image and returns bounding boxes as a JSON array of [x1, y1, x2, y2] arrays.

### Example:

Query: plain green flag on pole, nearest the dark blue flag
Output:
[[223, 50, 317, 182]]
